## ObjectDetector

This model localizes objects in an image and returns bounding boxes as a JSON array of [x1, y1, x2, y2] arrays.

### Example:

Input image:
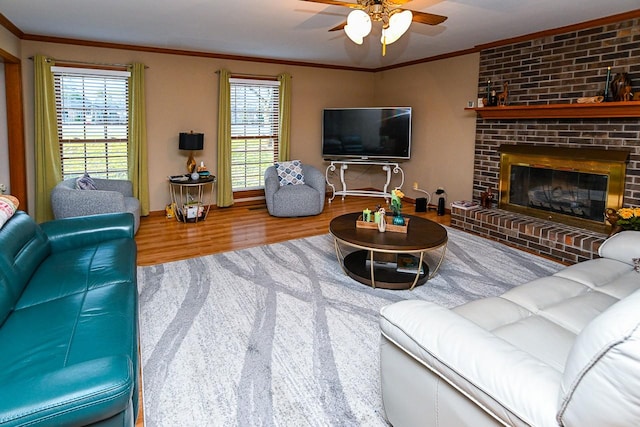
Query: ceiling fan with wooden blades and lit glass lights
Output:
[[301, 0, 447, 56]]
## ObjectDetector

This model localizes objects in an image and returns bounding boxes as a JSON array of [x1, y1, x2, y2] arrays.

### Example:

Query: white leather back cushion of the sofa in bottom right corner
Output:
[[557, 291, 640, 426]]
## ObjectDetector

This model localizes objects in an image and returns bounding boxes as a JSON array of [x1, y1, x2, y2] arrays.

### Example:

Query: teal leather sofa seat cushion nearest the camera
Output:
[[0, 283, 136, 384]]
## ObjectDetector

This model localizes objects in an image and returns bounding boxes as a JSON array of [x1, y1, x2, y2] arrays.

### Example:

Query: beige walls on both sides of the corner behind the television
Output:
[[12, 41, 478, 211]]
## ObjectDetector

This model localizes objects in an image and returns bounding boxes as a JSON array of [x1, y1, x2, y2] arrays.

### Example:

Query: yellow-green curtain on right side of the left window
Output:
[[128, 63, 149, 216]]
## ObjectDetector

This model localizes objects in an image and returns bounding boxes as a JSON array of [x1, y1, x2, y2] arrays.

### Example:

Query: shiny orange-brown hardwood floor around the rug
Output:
[[136, 196, 451, 427]]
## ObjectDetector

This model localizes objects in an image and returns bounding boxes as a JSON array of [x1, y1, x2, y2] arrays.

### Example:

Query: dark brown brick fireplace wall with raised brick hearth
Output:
[[451, 13, 640, 263]]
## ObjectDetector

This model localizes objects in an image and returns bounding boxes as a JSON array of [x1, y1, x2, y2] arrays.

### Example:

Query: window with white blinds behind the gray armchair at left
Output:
[[52, 67, 129, 179]]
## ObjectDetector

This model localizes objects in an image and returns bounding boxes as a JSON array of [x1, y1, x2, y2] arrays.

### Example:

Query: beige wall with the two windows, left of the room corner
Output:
[[22, 41, 373, 211]]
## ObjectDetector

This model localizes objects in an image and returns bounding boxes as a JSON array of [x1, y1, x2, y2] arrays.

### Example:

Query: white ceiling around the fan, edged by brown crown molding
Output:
[[5, 0, 640, 69]]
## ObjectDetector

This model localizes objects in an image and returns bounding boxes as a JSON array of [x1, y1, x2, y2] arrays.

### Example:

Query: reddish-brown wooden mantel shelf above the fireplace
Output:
[[465, 101, 640, 120]]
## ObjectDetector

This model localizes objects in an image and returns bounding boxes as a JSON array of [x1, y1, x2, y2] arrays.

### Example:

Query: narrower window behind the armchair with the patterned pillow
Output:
[[230, 78, 280, 191]]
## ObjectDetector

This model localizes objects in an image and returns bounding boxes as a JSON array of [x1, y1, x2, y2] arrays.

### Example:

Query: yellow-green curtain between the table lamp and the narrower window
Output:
[[216, 70, 233, 207]]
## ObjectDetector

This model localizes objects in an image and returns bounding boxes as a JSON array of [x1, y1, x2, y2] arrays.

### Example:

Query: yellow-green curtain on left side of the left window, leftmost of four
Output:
[[33, 55, 62, 222]]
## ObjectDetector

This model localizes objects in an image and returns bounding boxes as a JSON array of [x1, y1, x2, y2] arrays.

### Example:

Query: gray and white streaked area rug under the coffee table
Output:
[[138, 228, 562, 427]]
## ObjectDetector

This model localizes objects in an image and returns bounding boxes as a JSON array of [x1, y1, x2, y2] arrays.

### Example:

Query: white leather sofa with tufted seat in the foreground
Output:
[[380, 231, 640, 427]]
